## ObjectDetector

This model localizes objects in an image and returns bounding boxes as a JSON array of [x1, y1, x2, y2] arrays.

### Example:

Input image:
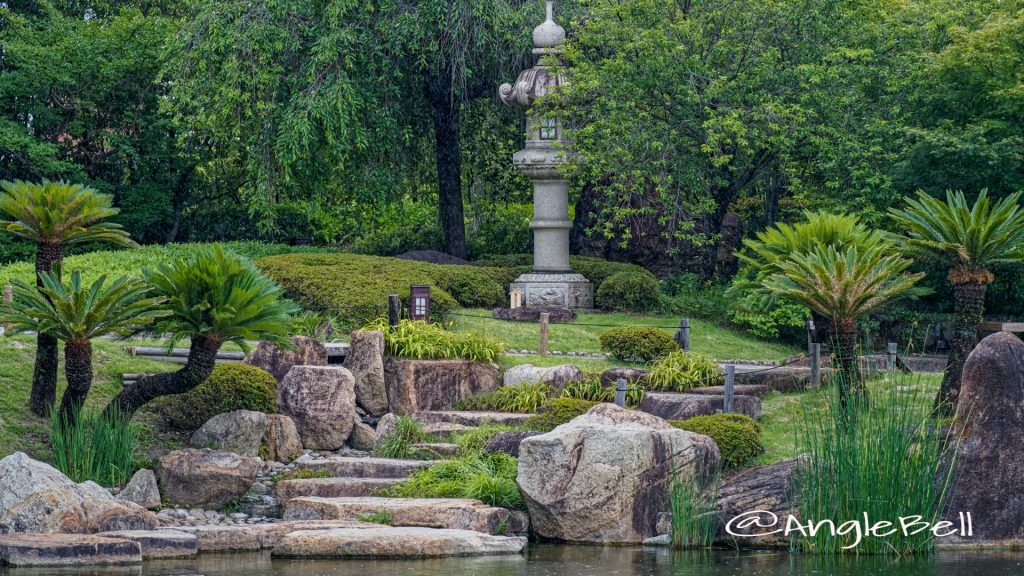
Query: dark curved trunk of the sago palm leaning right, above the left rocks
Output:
[[103, 334, 222, 420]]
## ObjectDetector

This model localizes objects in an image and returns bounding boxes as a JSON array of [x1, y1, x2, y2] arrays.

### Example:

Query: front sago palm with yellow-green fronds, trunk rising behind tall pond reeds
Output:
[[760, 242, 927, 405]]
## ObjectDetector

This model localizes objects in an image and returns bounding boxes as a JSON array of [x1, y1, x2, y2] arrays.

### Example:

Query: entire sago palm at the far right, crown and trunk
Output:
[[891, 191, 1024, 414]]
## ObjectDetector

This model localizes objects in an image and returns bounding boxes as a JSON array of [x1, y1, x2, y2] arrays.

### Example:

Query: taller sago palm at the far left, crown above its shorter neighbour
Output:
[[0, 180, 137, 416]]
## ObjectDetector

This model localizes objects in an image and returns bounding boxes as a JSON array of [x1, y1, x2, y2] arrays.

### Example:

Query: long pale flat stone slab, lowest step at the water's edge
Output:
[[271, 527, 526, 559]]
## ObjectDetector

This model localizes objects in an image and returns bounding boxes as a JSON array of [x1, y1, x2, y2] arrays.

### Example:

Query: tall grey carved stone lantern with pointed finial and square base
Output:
[[498, 0, 594, 308]]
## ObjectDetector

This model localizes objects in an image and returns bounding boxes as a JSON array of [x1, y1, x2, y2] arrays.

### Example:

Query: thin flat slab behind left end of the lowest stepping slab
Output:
[[168, 520, 380, 552]]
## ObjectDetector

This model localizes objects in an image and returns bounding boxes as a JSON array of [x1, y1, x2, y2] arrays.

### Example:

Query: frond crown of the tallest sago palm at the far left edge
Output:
[[0, 180, 137, 247]]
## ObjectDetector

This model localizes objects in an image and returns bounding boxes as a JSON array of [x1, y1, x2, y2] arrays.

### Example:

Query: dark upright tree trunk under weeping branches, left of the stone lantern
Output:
[[427, 77, 466, 258]]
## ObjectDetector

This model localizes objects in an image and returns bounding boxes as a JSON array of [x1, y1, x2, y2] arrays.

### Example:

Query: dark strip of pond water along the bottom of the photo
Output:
[[0, 545, 1024, 576]]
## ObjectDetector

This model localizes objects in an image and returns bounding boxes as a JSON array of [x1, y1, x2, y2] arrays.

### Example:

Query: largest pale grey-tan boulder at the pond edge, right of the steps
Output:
[[516, 404, 719, 543]]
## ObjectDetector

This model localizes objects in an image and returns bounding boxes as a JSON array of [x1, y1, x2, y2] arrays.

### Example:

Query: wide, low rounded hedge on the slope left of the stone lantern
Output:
[[256, 253, 512, 327]]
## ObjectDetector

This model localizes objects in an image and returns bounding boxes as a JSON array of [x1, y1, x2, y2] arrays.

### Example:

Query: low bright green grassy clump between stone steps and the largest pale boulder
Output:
[[387, 453, 526, 509]]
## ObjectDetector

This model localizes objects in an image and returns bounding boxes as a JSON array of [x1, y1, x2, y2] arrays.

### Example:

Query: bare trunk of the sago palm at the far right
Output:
[[935, 280, 988, 416]]
